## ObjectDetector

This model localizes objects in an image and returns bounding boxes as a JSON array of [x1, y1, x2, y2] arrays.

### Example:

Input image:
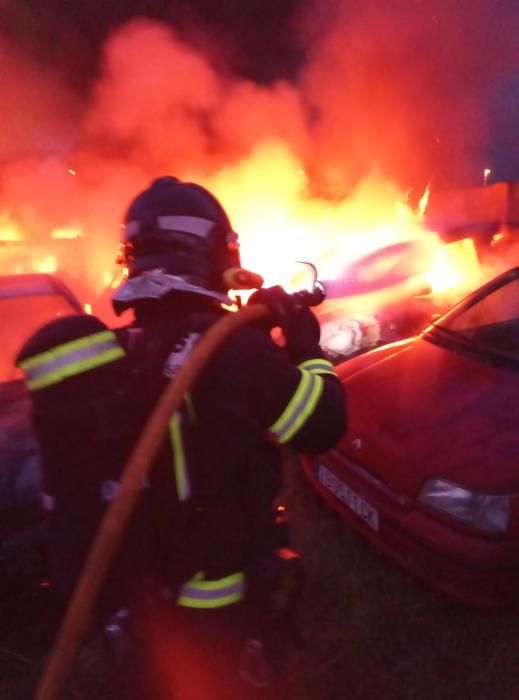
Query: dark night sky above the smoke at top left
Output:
[[2, 0, 306, 83]]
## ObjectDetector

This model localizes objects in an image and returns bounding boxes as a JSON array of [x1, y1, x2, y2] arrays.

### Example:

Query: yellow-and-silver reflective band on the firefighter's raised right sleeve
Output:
[[269, 369, 324, 443]]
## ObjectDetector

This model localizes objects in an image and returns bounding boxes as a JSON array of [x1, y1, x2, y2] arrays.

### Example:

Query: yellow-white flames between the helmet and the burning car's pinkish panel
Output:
[[207, 142, 437, 285]]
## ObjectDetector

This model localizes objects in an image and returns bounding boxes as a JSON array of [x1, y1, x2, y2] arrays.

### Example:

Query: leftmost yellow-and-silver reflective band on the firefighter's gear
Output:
[[20, 331, 125, 391]]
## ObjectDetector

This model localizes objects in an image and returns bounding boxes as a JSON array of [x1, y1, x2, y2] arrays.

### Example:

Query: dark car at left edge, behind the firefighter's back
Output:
[[0, 274, 83, 572]]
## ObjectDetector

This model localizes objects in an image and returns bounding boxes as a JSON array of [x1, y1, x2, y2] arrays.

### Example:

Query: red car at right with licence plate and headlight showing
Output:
[[305, 268, 519, 607]]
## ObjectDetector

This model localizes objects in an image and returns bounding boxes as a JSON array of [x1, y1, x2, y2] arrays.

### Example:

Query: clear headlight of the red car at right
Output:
[[418, 478, 510, 533]]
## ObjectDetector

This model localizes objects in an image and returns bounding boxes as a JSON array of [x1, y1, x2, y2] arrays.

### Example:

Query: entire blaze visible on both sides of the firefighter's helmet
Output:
[[0, 142, 492, 330]]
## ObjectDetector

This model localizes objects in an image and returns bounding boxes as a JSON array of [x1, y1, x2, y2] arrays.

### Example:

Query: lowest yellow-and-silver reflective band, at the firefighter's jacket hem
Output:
[[177, 571, 245, 609]]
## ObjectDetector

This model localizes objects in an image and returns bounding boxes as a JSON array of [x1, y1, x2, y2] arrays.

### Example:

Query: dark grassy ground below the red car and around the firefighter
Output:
[[0, 462, 519, 700]]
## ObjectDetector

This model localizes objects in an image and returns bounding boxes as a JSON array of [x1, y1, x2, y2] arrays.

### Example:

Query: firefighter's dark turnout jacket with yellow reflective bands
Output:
[[18, 298, 345, 607]]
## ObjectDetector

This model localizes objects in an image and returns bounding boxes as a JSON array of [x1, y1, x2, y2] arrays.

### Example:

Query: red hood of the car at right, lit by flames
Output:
[[338, 337, 519, 497]]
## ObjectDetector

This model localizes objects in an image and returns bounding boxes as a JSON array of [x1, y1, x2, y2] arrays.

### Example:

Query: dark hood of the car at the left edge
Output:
[[0, 381, 41, 510]]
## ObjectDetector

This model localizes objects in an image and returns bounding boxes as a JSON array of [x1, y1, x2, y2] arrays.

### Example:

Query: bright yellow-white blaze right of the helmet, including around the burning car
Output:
[[207, 143, 488, 311]]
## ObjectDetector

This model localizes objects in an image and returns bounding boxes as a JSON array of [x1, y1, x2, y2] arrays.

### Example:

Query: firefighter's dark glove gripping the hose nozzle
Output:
[[247, 286, 322, 364]]
